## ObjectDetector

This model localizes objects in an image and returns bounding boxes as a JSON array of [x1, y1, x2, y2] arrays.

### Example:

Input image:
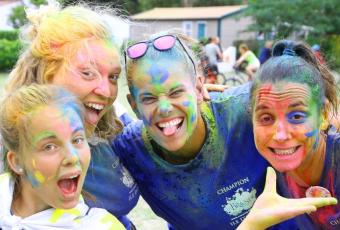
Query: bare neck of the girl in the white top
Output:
[[11, 179, 48, 218]]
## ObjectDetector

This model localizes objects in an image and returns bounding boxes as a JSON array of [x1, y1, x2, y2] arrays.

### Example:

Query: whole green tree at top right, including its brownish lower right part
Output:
[[247, 0, 340, 69]]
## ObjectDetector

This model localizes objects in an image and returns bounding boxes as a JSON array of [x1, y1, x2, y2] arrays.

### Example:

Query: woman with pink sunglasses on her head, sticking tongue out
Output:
[[112, 34, 329, 230]]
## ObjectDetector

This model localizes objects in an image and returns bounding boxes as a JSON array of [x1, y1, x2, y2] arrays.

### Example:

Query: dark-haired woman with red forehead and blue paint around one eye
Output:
[[251, 41, 340, 229]]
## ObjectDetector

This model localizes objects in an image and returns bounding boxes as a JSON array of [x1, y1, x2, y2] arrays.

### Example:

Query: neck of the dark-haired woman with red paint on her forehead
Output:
[[287, 134, 326, 187]]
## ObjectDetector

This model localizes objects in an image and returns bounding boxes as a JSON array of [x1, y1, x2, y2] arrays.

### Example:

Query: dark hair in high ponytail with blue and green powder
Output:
[[251, 40, 338, 117]]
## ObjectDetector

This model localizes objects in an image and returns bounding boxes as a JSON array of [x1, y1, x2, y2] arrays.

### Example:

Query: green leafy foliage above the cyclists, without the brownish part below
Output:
[[248, 0, 340, 37]]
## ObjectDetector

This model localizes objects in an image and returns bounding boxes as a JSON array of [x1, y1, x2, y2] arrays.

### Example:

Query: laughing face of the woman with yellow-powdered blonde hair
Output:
[[52, 39, 121, 132]]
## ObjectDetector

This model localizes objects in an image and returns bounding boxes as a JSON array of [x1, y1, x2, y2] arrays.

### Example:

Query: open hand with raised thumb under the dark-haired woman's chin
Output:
[[237, 167, 337, 230]]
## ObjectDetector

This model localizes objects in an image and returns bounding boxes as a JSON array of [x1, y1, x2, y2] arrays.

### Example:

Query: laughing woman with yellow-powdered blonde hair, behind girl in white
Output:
[[6, 5, 139, 229]]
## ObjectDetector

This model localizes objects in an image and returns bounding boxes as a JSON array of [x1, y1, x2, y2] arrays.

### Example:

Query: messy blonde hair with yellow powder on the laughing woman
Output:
[[5, 1, 123, 138]]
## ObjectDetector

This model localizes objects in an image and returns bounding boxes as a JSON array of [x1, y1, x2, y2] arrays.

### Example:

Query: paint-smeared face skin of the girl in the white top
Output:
[[19, 105, 90, 212]]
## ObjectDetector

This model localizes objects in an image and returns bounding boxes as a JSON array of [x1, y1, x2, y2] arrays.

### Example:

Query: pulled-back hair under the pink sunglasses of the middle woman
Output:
[[125, 31, 201, 95]]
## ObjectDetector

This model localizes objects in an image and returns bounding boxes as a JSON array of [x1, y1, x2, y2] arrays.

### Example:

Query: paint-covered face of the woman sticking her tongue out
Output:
[[130, 57, 198, 151]]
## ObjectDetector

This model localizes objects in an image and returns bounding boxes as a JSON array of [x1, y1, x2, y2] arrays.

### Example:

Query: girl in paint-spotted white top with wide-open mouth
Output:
[[0, 84, 125, 230]]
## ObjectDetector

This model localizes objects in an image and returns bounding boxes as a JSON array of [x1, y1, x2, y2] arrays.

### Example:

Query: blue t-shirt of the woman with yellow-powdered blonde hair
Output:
[[84, 140, 139, 229]]
